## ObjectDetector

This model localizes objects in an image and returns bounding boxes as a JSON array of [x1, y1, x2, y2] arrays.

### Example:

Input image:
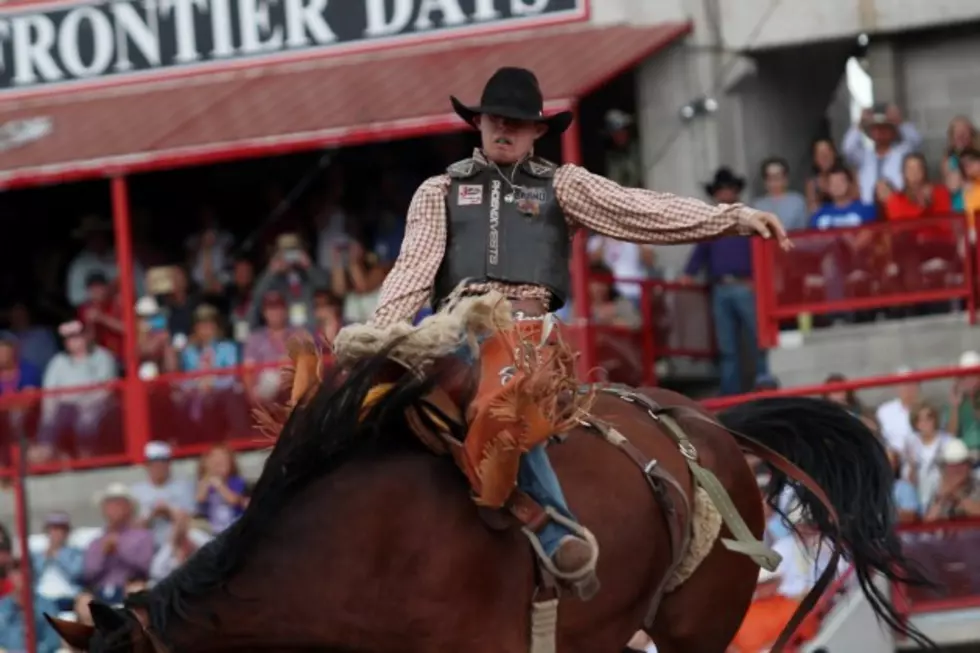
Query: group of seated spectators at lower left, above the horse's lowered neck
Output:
[[0, 441, 249, 653]]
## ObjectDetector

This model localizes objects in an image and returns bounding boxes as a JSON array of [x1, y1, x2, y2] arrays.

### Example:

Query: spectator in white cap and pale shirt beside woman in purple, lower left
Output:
[[132, 441, 197, 547]]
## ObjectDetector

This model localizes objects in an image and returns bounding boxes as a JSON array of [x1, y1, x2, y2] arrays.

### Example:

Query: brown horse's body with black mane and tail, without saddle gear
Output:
[[52, 344, 926, 653]]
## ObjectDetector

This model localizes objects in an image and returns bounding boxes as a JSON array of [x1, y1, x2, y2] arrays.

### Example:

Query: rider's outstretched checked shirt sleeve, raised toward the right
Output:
[[555, 165, 759, 244]]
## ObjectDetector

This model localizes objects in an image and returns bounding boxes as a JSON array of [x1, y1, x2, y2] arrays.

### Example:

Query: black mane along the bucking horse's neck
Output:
[[133, 343, 462, 636]]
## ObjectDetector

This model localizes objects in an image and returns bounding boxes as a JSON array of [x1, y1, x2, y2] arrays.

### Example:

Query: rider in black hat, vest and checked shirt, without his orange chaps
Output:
[[372, 68, 789, 592]]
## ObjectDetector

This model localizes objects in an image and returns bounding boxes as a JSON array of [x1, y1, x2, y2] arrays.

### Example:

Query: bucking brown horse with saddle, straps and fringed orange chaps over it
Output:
[[50, 294, 929, 653]]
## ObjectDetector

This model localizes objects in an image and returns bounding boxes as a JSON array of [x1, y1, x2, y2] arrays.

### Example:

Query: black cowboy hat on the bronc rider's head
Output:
[[449, 68, 572, 134]]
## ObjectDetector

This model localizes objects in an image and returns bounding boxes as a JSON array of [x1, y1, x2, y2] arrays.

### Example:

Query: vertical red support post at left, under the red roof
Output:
[[110, 176, 150, 464]]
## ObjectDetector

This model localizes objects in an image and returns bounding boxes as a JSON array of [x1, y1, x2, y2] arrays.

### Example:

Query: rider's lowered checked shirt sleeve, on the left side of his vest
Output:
[[371, 175, 449, 327]]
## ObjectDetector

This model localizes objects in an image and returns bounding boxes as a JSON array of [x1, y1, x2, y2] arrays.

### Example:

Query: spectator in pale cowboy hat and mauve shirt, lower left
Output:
[[75, 483, 153, 610]]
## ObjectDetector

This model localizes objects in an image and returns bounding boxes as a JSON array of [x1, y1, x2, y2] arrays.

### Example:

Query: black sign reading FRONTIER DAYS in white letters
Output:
[[0, 0, 589, 93]]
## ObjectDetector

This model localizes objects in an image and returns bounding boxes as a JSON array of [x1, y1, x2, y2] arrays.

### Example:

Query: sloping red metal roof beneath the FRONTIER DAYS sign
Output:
[[0, 23, 689, 187]]
